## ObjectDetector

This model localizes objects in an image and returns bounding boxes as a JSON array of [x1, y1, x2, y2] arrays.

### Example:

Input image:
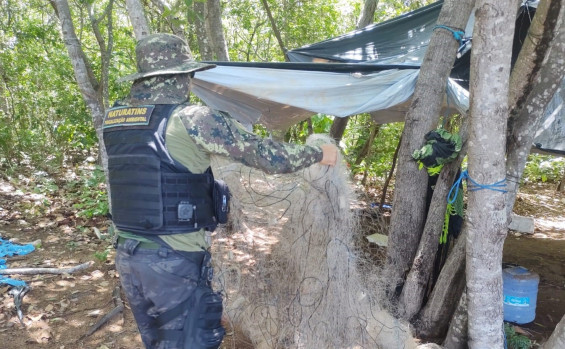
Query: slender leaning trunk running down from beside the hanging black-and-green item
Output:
[[399, 118, 468, 320]]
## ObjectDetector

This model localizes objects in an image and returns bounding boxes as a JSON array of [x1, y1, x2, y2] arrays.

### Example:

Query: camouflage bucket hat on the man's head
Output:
[[117, 34, 216, 82]]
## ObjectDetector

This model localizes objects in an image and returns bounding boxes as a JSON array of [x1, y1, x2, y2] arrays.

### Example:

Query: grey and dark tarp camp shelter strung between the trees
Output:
[[193, 1, 565, 154]]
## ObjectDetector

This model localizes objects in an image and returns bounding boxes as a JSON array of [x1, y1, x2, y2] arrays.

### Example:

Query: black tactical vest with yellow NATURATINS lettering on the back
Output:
[[103, 104, 217, 235]]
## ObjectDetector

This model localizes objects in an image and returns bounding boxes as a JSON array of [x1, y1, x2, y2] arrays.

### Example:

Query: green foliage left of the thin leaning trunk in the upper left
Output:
[[0, 0, 97, 171]]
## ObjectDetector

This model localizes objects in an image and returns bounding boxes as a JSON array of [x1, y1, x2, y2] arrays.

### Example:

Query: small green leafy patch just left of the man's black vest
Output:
[[67, 166, 108, 218]]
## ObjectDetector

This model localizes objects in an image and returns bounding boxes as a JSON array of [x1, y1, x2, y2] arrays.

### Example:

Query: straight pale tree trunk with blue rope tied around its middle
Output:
[[465, 0, 515, 349]]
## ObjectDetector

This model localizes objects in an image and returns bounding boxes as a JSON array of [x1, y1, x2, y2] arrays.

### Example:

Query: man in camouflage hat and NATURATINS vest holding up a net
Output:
[[103, 34, 337, 349]]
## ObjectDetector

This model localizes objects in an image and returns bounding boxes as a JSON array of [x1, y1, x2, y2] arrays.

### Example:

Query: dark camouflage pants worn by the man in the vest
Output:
[[116, 239, 204, 349]]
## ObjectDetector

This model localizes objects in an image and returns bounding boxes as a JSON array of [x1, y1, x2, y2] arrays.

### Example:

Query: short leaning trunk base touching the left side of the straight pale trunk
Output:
[[414, 230, 467, 339]]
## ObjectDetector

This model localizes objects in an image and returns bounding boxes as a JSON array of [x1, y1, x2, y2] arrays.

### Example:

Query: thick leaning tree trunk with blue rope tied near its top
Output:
[[385, 0, 474, 300]]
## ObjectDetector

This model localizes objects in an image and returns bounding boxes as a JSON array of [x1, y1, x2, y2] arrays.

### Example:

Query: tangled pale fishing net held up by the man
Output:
[[212, 136, 415, 349]]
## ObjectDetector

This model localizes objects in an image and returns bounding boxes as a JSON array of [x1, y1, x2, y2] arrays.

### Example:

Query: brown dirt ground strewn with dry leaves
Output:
[[0, 180, 565, 349]]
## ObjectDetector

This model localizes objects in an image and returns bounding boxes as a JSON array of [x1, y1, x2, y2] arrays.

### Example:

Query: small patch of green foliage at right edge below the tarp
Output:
[[522, 154, 565, 183]]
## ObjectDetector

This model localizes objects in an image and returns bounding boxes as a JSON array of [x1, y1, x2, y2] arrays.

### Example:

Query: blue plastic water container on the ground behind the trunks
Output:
[[502, 266, 539, 324]]
